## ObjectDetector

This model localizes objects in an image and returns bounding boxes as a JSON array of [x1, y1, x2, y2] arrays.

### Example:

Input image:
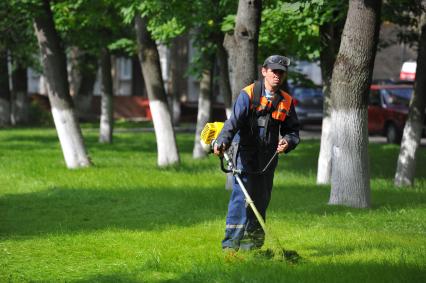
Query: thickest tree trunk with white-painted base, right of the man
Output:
[[329, 0, 381, 208]]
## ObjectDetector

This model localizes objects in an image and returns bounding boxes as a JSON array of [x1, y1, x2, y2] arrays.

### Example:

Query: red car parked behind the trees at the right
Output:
[[368, 85, 413, 143]]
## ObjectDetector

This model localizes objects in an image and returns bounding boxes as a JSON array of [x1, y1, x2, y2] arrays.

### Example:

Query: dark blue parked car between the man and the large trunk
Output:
[[290, 86, 324, 127]]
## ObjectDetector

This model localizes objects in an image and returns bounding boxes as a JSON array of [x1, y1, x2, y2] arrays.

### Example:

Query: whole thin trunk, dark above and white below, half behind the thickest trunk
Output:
[[317, 23, 341, 185]]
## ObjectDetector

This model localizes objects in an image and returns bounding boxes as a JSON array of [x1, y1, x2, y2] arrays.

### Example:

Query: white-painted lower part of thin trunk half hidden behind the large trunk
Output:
[[317, 117, 332, 185]]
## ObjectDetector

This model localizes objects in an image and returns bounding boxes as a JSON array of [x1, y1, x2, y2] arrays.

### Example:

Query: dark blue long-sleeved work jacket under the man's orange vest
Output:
[[217, 84, 300, 153]]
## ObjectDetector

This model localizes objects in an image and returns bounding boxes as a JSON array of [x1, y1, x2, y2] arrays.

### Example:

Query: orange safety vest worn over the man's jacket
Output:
[[243, 83, 292, 122]]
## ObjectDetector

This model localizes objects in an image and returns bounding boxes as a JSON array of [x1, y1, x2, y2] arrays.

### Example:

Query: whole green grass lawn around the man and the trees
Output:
[[0, 126, 426, 282]]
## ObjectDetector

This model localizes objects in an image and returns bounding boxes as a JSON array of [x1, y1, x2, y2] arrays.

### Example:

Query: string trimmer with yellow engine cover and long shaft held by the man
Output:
[[201, 122, 300, 263]]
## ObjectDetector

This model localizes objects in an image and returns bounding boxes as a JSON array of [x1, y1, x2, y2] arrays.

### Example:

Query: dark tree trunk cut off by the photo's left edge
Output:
[[0, 52, 10, 127]]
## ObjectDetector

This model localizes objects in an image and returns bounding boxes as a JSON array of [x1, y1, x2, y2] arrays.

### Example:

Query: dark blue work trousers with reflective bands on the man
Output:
[[222, 151, 278, 250]]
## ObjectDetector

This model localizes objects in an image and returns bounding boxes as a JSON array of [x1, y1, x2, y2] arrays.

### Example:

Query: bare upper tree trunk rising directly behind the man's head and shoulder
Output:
[[224, 0, 262, 101]]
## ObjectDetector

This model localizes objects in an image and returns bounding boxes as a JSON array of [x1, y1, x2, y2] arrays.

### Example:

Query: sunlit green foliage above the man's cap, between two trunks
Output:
[[259, 0, 347, 61]]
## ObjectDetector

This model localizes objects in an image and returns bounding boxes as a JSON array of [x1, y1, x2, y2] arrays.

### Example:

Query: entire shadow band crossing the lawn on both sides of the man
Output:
[[0, 184, 426, 240]]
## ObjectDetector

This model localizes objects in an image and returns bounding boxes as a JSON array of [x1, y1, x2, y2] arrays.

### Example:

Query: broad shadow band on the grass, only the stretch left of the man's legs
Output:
[[0, 188, 227, 237]]
